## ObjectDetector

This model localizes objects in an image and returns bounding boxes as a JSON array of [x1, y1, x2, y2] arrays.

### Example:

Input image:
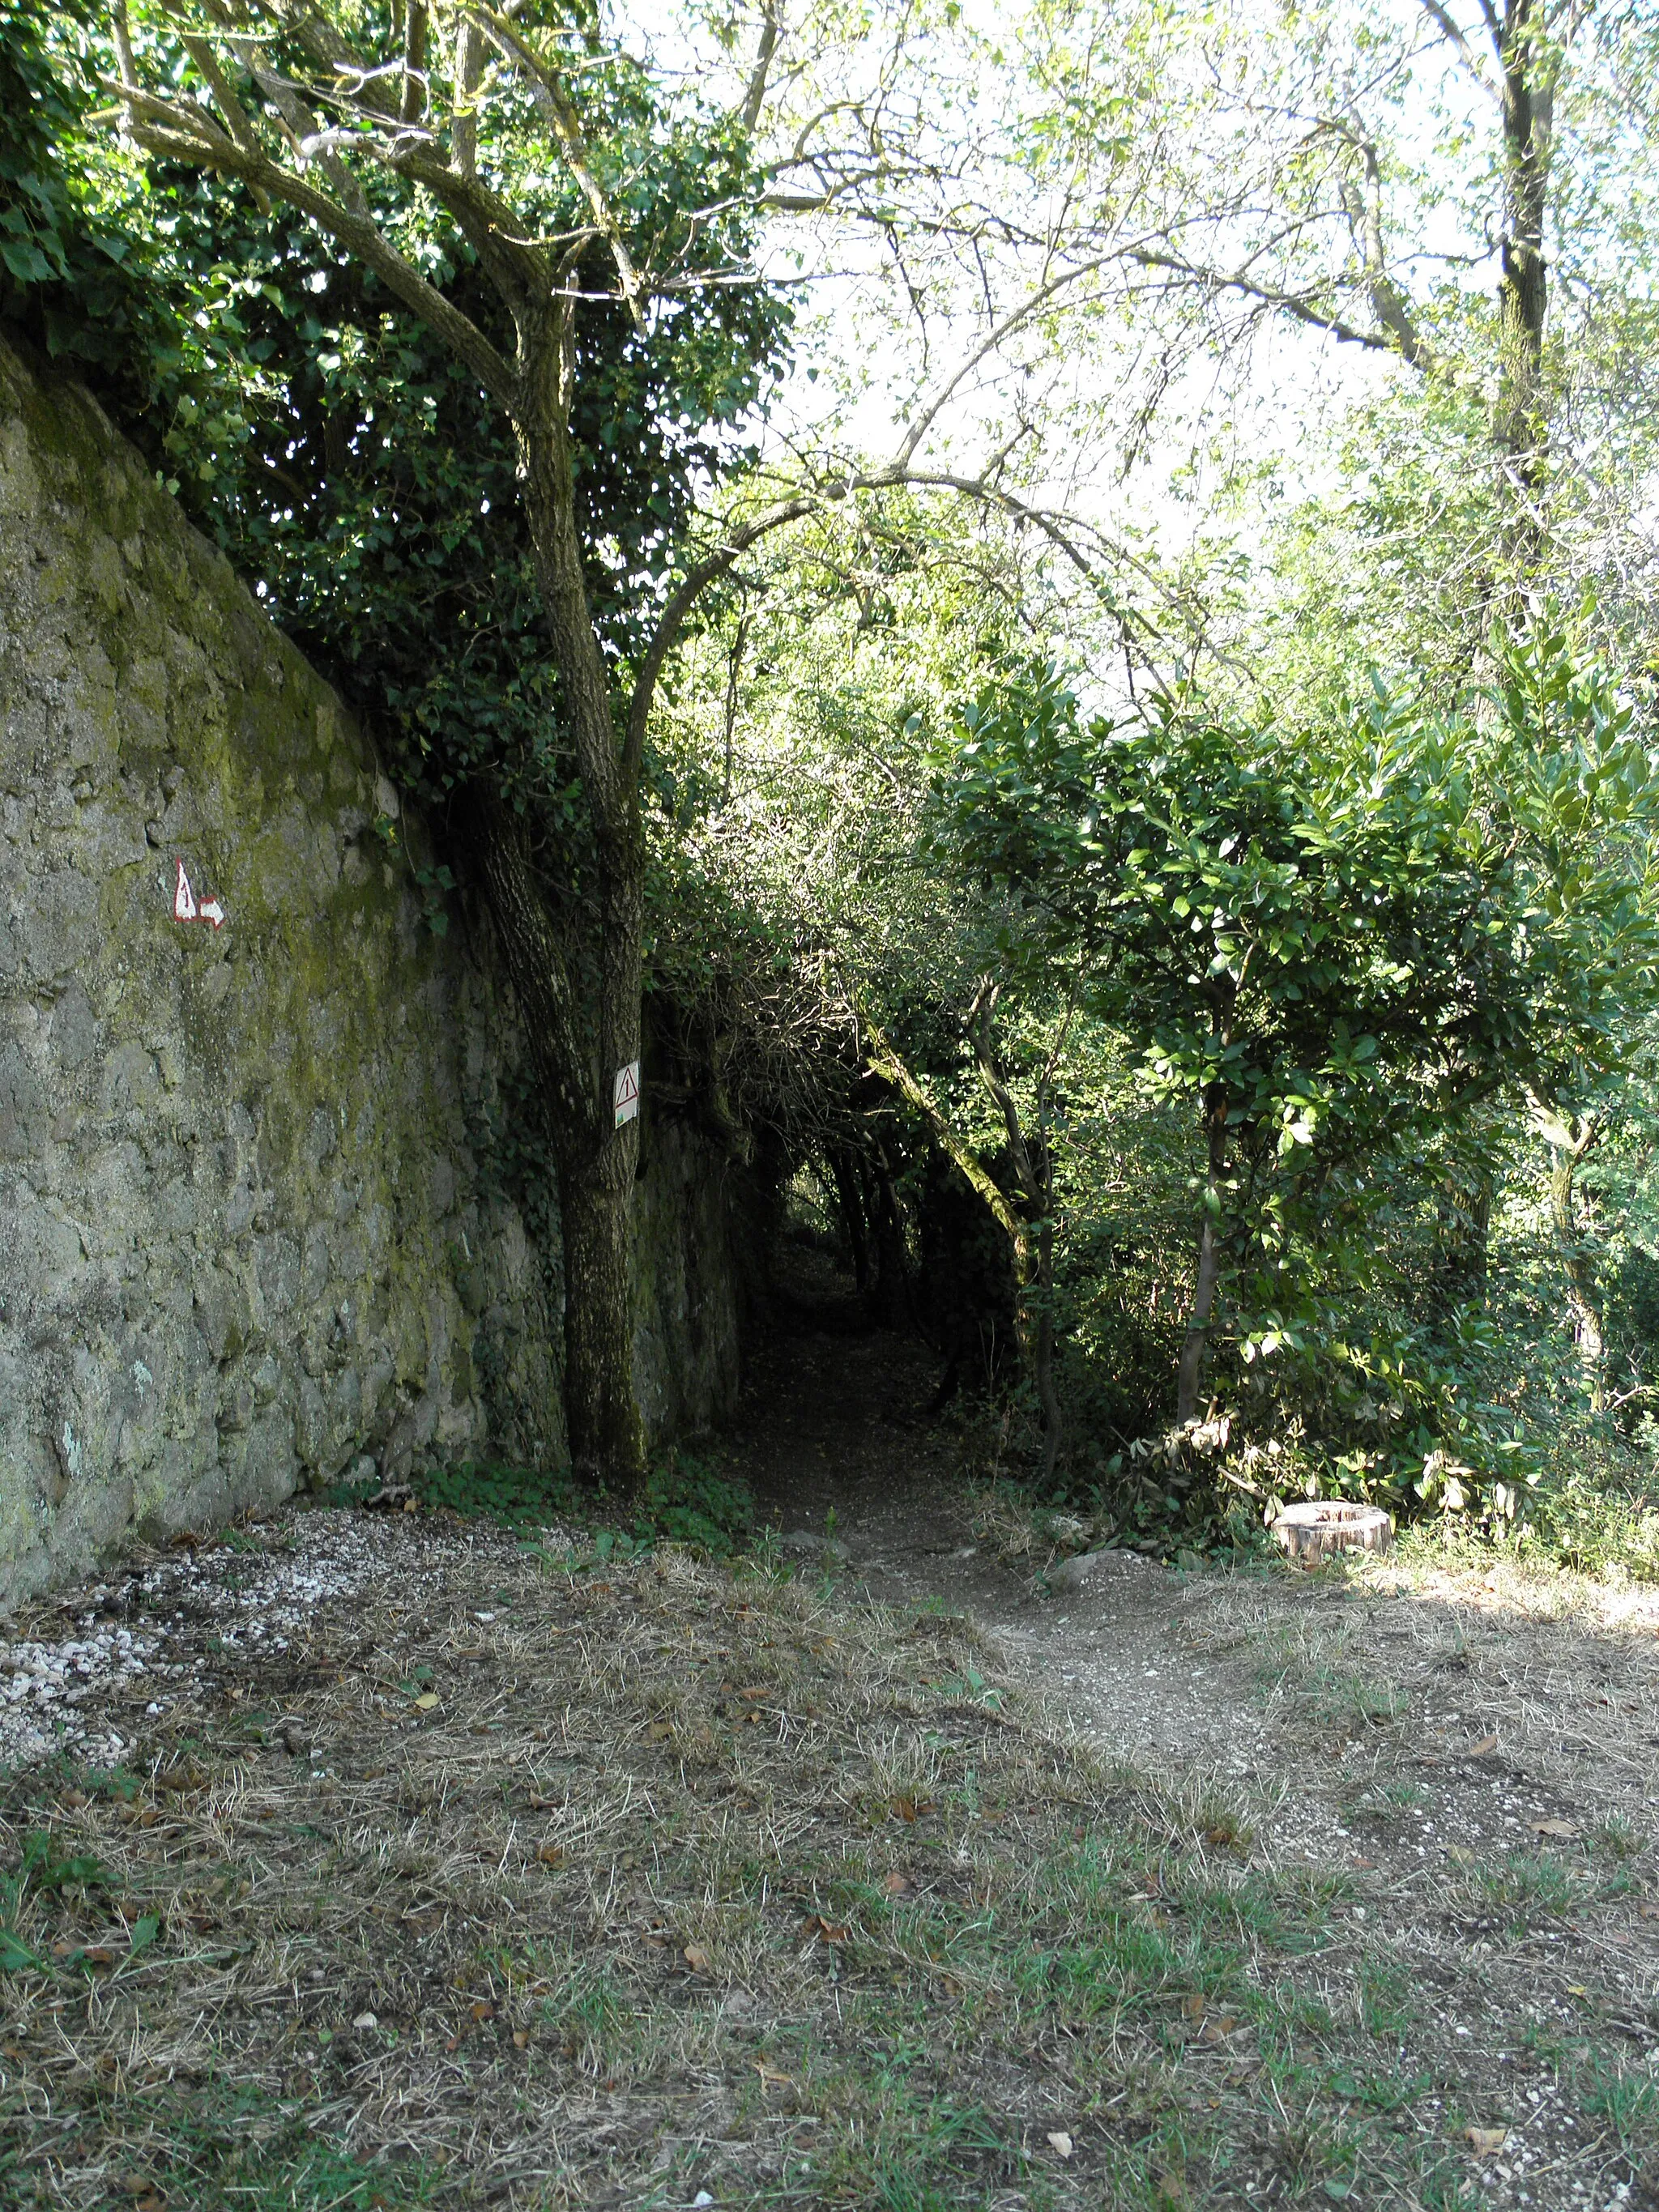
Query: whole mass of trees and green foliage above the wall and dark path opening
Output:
[[0, 0, 1659, 1542]]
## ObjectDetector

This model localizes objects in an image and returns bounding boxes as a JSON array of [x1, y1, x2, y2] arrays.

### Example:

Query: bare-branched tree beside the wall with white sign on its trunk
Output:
[[102, 0, 1119, 1485]]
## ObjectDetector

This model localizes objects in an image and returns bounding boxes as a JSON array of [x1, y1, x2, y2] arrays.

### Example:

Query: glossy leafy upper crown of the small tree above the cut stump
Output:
[[938, 621, 1659, 1159]]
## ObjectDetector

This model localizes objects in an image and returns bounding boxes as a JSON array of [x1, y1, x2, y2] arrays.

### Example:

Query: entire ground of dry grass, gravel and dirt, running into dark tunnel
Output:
[[0, 1274, 1659, 2212]]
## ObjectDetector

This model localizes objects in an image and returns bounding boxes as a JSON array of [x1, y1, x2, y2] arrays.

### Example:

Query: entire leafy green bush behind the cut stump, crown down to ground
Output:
[[929, 615, 1659, 1528]]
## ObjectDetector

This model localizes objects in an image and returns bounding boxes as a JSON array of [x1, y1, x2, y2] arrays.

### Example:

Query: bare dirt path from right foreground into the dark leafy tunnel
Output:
[[727, 1305, 1659, 2208]]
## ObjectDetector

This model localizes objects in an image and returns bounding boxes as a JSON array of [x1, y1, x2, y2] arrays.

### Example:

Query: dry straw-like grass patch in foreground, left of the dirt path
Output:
[[0, 1519, 1659, 2212]]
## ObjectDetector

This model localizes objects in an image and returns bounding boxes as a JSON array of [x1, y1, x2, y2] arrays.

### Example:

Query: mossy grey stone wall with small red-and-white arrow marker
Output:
[[0, 331, 739, 1604]]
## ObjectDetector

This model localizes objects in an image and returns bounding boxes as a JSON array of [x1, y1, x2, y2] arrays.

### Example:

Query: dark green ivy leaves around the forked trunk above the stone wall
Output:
[[89, 53, 792, 822]]
